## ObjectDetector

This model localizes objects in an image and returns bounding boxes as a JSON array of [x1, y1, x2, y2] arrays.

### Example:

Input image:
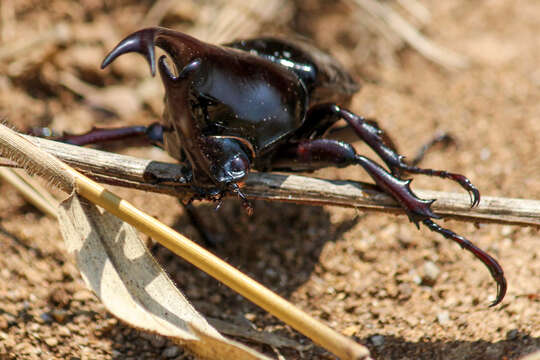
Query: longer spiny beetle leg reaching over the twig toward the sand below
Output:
[[264, 139, 506, 306]]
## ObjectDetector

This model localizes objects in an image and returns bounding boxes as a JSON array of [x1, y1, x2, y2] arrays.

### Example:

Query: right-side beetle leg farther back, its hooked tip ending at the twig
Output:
[[306, 104, 480, 207]]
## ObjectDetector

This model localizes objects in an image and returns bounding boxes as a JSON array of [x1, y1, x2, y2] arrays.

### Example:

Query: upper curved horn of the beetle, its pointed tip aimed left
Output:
[[101, 27, 205, 76]]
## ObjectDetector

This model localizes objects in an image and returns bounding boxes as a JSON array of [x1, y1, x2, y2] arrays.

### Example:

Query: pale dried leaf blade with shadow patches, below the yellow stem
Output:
[[59, 195, 266, 359]]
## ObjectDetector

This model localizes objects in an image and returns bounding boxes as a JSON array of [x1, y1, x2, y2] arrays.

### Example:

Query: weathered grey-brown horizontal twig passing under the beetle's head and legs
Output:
[[4, 136, 540, 226]]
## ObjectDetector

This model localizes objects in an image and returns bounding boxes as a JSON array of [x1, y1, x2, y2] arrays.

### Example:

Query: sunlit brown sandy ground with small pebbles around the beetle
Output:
[[0, 0, 540, 359]]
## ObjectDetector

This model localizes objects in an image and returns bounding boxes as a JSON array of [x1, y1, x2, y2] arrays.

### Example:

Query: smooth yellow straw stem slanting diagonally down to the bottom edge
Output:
[[61, 167, 369, 359]]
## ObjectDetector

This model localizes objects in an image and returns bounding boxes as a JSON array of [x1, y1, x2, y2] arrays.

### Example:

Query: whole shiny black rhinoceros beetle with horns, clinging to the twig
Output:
[[62, 27, 506, 306]]
